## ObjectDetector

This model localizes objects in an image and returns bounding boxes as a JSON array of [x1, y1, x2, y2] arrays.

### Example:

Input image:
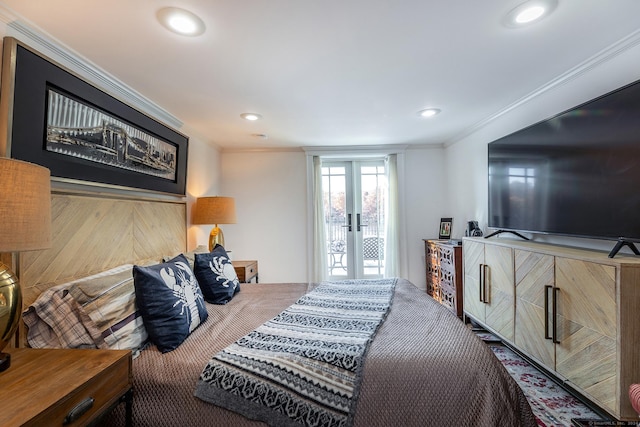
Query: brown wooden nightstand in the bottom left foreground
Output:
[[0, 348, 133, 426]]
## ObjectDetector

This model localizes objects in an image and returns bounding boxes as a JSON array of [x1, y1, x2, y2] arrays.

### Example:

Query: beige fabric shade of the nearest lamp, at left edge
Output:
[[0, 157, 51, 252]]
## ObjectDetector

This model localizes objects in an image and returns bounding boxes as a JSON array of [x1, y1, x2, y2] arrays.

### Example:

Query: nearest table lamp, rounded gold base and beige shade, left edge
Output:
[[0, 157, 51, 372]]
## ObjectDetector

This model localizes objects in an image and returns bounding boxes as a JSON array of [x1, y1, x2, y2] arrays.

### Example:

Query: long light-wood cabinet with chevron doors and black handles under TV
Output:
[[463, 237, 640, 425]]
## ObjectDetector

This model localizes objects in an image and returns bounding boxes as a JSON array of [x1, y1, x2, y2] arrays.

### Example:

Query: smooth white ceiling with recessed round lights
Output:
[[0, 0, 640, 149]]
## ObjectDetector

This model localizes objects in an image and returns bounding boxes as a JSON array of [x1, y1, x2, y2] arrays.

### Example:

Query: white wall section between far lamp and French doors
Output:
[[220, 150, 307, 282]]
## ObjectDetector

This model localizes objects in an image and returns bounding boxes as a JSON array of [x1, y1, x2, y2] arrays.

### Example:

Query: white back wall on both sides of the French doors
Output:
[[220, 148, 451, 288]]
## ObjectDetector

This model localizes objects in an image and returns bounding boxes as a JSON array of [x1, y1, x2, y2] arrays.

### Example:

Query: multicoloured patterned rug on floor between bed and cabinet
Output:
[[474, 330, 602, 427]]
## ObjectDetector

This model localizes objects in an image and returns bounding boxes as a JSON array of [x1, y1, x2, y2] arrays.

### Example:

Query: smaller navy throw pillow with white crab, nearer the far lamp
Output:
[[194, 245, 240, 304]]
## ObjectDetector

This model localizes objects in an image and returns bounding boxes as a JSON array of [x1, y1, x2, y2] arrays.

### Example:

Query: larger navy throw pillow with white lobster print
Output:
[[133, 255, 208, 353]]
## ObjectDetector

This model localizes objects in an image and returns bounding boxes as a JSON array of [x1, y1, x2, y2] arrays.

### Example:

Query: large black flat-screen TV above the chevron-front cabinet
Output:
[[488, 81, 640, 240]]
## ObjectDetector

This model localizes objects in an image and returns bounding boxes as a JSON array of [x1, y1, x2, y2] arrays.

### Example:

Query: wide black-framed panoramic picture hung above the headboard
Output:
[[0, 37, 189, 196]]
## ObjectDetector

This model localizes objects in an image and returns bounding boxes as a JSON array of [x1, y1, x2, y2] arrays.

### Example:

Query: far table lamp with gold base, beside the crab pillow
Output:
[[193, 196, 236, 251]]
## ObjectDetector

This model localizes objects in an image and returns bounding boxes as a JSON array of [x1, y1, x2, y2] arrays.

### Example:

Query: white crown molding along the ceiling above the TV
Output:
[[444, 29, 640, 147]]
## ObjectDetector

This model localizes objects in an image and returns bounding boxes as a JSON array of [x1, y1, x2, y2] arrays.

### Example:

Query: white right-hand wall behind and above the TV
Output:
[[446, 38, 640, 252]]
